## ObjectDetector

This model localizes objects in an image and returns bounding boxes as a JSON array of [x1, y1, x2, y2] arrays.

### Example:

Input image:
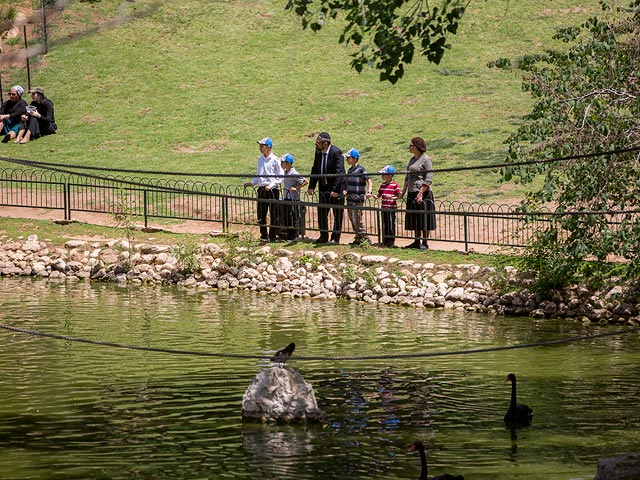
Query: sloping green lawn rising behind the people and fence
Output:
[[0, 0, 599, 202]]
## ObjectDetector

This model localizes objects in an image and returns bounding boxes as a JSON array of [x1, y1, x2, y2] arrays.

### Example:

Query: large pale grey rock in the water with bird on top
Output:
[[242, 367, 321, 422]]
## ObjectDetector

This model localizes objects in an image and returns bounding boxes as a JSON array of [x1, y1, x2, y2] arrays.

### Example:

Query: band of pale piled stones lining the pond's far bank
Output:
[[0, 235, 640, 325]]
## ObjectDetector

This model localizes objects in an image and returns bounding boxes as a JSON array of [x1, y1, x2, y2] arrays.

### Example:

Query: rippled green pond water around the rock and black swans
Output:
[[0, 278, 640, 480]]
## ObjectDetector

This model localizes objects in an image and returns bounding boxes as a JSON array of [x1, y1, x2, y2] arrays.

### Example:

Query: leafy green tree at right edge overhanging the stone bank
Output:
[[492, 0, 640, 287]]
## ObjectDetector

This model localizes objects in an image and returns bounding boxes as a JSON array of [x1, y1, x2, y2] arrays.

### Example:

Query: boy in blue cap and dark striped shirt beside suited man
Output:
[[342, 148, 373, 245]]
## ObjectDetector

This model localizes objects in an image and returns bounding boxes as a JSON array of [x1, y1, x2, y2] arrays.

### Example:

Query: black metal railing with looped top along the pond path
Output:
[[0, 169, 547, 250]]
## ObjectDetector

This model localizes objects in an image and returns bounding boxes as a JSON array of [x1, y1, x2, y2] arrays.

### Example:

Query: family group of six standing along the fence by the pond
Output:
[[245, 132, 436, 250]]
